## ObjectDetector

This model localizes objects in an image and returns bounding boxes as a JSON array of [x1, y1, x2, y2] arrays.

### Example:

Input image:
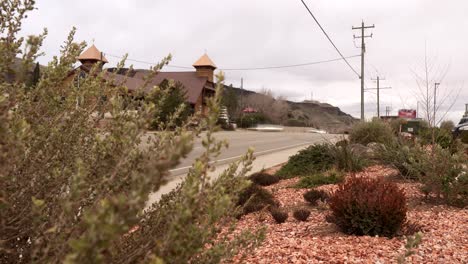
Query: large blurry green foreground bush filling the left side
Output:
[[0, 0, 260, 263]]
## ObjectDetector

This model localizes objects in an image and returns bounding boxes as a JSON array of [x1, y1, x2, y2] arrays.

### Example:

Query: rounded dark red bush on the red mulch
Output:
[[329, 177, 407, 237]]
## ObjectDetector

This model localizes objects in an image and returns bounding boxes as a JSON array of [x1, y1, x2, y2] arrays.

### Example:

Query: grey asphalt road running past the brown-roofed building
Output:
[[171, 131, 341, 176]]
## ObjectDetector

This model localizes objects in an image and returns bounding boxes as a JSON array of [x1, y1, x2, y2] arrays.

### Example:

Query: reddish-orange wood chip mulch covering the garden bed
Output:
[[234, 166, 468, 264]]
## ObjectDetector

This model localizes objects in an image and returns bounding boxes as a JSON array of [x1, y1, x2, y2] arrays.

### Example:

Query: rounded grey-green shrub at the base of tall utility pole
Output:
[[349, 121, 395, 146]]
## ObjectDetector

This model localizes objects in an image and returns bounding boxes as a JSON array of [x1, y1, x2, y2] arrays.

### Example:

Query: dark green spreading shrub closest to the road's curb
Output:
[[276, 144, 334, 179]]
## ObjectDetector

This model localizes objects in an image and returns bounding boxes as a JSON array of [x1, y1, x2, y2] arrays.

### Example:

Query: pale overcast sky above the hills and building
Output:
[[22, 0, 468, 121]]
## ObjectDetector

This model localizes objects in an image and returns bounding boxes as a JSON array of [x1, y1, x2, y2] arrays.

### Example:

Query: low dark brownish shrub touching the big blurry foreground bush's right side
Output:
[[237, 184, 277, 214]]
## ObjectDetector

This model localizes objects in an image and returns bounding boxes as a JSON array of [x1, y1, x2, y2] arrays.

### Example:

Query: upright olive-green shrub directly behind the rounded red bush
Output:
[[330, 141, 369, 172]]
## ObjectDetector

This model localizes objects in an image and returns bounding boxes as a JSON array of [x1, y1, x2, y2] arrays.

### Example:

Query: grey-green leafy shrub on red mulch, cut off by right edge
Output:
[[421, 147, 468, 206]]
